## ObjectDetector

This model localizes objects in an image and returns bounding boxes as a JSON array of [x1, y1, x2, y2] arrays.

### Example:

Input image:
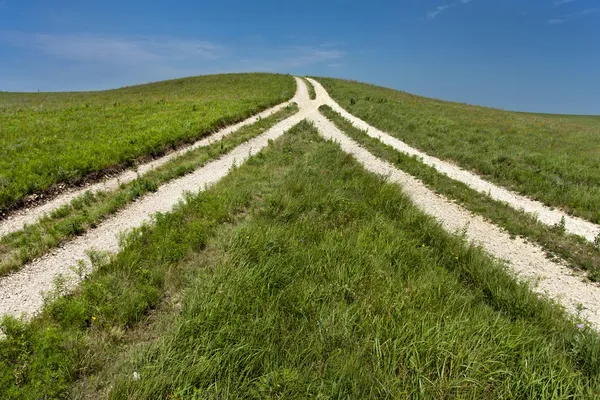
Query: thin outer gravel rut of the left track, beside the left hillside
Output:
[[0, 98, 298, 237]]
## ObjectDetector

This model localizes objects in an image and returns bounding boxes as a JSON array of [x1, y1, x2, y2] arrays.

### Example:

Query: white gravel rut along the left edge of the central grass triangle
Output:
[[0, 79, 308, 318]]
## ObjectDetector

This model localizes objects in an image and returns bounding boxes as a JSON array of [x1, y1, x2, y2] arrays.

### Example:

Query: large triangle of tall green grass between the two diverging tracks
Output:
[[0, 124, 600, 399]]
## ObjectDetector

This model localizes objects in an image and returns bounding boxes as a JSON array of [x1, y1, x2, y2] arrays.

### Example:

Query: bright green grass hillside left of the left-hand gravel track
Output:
[[0, 74, 295, 215]]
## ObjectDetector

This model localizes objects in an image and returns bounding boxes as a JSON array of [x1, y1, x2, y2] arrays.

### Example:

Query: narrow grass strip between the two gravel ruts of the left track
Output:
[[0, 105, 298, 276]]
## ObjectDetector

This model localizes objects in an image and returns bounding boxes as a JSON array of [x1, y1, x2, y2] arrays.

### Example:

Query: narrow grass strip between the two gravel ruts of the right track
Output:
[[319, 106, 600, 282]]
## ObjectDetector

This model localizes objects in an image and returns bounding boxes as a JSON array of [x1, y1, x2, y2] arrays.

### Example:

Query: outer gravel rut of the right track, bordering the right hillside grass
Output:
[[309, 78, 600, 242]]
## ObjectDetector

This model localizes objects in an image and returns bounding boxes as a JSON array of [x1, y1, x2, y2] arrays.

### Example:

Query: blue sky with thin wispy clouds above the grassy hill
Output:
[[0, 0, 600, 114]]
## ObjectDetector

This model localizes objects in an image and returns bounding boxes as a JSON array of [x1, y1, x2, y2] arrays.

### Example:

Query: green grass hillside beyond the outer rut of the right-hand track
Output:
[[318, 78, 600, 223]]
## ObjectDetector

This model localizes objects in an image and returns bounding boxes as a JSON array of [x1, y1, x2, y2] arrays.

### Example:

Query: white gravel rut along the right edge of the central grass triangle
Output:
[[309, 112, 600, 329]]
